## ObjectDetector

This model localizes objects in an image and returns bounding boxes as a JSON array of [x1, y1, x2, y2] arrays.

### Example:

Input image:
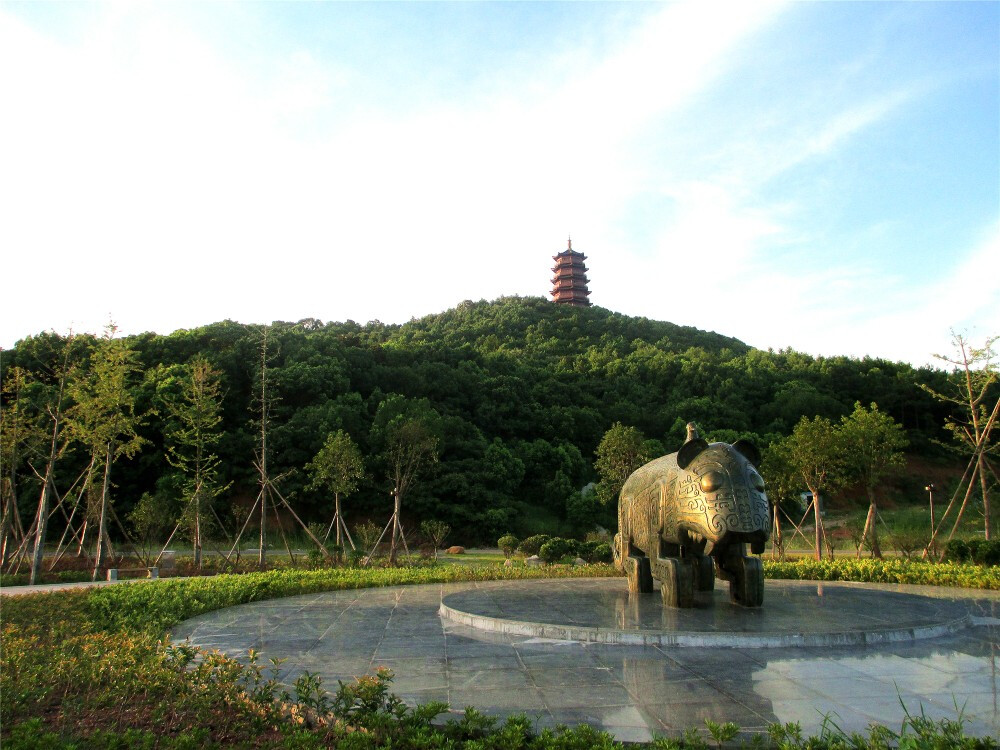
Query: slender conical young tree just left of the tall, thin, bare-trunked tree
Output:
[[161, 355, 229, 570]]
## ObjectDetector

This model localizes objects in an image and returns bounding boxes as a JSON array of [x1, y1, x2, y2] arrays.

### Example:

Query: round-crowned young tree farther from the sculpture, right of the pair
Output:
[[840, 402, 909, 557]]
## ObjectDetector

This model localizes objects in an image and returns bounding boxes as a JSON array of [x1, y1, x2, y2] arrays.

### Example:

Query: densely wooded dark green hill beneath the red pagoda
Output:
[[2, 298, 945, 542]]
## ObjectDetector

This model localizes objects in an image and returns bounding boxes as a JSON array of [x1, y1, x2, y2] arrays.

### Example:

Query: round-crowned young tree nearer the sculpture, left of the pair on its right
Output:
[[774, 417, 845, 560]]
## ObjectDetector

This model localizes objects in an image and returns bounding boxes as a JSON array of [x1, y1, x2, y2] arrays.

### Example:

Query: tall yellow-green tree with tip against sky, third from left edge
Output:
[[67, 324, 148, 580]]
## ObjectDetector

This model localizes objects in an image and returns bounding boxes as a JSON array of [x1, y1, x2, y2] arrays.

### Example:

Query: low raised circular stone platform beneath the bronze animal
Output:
[[440, 578, 972, 648]]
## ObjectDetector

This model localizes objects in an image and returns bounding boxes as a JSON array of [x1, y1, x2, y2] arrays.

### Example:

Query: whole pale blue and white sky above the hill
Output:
[[0, 0, 1000, 366]]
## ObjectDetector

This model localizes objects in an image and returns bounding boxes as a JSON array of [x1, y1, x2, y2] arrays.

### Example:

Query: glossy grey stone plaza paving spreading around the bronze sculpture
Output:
[[172, 579, 1000, 741]]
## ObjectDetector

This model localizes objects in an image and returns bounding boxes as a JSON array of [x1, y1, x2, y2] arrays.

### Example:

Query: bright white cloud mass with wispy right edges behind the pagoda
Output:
[[0, 3, 988, 376]]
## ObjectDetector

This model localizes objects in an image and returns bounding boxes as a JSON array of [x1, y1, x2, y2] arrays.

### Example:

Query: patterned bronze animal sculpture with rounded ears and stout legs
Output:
[[614, 424, 771, 607]]
